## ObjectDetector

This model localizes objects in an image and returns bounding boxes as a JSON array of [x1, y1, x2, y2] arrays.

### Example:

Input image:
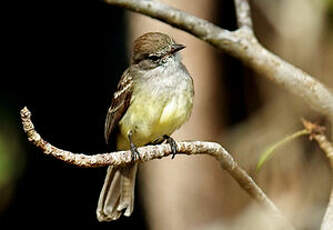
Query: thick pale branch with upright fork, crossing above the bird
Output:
[[105, 0, 333, 118]]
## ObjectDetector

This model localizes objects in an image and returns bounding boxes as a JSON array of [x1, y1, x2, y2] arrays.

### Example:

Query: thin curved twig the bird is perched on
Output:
[[21, 107, 293, 229]]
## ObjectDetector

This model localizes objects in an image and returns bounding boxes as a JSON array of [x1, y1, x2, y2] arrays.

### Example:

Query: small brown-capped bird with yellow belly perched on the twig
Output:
[[96, 32, 194, 221]]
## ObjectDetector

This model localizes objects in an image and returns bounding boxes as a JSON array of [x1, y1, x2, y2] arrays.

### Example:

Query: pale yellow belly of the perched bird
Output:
[[117, 94, 192, 150]]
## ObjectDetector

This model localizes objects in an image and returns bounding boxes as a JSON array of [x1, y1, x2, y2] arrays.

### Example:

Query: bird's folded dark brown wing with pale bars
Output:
[[104, 69, 134, 143]]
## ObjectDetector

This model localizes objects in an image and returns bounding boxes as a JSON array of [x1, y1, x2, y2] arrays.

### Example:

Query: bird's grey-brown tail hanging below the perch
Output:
[[96, 163, 137, 221]]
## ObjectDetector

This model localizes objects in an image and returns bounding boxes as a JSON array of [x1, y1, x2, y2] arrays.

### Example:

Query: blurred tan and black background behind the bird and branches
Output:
[[0, 0, 333, 230]]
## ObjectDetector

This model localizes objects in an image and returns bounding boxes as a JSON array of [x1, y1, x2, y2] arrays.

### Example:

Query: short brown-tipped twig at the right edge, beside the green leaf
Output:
[[302, 120, 333, 230]]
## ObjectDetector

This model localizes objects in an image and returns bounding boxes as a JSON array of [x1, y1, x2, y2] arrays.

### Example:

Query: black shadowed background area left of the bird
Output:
[[0, 1, 145, 229]]
